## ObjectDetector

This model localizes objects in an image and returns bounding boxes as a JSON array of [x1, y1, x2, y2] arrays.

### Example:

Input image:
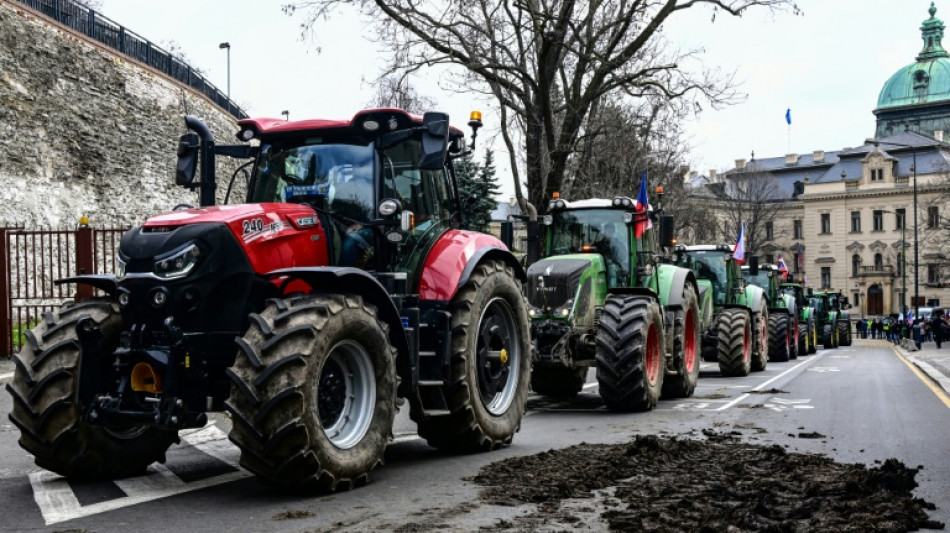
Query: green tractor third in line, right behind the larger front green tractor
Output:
[[673, 244, 769, 376]]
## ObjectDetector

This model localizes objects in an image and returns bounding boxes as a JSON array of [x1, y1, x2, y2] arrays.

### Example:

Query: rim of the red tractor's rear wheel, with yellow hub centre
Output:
[[475, 298, 522, 416]]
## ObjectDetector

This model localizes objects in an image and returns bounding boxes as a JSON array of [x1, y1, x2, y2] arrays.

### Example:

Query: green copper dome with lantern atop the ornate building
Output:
[[874, 3, 950, 140]]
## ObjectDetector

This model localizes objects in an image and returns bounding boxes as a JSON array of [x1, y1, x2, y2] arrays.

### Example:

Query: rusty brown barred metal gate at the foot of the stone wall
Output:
[[0, 226, 128, 358]]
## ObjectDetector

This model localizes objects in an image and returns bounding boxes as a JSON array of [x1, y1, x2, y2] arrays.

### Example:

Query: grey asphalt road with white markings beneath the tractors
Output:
[[0, 341, 950, 532]]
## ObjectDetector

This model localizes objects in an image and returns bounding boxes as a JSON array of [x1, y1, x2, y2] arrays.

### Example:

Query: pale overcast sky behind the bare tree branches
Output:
[[101, 0, 928, 196]]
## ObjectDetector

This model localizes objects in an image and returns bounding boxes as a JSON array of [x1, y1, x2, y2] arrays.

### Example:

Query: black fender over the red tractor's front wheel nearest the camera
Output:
[[264, 267, 411, 361]]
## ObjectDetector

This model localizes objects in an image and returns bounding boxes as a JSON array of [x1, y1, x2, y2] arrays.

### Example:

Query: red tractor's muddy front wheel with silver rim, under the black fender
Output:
[[227, 295, 398, 491]]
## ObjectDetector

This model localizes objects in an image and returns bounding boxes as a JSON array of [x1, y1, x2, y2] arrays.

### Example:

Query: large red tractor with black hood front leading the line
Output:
[[7, 109, 531, 490]]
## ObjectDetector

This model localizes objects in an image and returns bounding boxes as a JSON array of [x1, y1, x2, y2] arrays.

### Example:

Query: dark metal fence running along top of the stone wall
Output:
[[16, 0, 247, 119]]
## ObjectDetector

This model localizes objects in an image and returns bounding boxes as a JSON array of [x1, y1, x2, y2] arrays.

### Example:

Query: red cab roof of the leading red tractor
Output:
[[238, 108, 464, 140]]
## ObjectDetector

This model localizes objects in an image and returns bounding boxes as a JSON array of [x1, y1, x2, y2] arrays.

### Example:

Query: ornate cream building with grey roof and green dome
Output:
[[714, 3, 950, 316]]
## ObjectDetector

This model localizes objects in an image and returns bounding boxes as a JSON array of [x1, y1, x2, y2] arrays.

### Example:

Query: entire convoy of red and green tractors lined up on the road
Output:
[[7, 105, 851, 491]]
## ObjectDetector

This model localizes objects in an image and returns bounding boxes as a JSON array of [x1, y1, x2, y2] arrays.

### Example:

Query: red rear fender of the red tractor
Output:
[[419, 230, 528, 302]]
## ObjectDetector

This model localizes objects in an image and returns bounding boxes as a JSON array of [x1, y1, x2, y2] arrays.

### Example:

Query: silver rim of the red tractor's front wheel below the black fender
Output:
[[317, 341, 376, 450]]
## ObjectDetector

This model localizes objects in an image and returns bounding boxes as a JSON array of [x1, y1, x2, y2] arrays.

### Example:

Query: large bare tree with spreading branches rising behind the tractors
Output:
[[284, 0, 798, 214]]
